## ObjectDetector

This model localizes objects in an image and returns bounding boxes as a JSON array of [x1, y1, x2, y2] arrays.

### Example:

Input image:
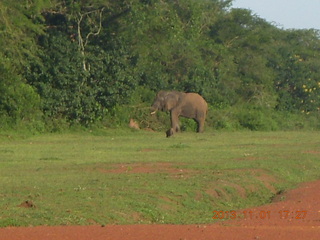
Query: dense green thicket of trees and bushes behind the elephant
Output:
[[0, 0, 320, 131]]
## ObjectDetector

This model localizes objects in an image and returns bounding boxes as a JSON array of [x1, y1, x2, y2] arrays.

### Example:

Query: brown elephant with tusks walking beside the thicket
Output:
[[151, 91, 208, 137]]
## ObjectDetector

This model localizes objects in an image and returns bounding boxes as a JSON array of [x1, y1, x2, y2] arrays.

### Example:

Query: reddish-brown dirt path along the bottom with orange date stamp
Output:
[[0, 181, 320, 240]]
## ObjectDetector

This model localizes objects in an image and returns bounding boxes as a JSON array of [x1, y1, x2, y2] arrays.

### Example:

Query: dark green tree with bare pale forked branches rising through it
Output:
[[27, 1, 134, 125]]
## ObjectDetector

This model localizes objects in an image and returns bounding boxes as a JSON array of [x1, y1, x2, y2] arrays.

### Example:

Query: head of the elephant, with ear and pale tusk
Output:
[[151, 91, 181, 114]]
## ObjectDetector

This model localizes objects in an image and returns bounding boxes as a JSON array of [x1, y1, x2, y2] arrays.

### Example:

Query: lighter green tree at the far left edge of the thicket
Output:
[[0, 0, 48, 126]]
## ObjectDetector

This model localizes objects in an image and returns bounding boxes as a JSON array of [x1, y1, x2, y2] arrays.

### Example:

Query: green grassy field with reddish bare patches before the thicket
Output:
[[0, 130, 320, 227]]
